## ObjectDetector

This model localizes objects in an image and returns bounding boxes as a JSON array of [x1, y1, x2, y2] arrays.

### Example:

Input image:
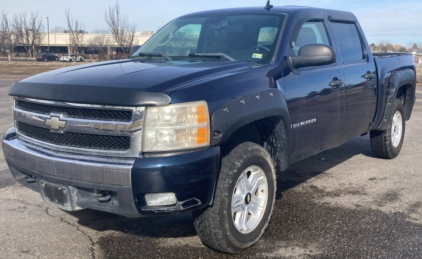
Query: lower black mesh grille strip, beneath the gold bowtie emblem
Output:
[[16, 121, 130, 151]]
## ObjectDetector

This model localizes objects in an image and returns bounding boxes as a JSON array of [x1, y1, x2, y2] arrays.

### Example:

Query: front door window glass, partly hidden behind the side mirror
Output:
[[293, 22, 330, 55]]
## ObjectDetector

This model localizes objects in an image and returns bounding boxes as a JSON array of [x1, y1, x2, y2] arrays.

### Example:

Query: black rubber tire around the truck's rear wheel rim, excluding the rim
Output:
[[370, 98, 406, 159]]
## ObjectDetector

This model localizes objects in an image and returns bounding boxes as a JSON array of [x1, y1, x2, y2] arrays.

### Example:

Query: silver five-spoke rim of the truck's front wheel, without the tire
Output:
[[231, 165, 268, 234]]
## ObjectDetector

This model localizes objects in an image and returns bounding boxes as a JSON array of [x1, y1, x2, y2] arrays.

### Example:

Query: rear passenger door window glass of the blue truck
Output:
[[331, 23, 364, 62]]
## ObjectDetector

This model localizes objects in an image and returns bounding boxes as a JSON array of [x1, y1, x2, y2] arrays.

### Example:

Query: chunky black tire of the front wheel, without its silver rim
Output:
[[194, 142, 276, 253]]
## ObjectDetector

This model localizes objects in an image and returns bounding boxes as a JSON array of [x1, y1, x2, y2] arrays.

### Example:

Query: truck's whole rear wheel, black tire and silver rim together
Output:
[[370, 99, 406, 159]]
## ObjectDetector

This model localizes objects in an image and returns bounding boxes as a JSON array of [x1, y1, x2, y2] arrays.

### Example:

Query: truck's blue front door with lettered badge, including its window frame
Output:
[[284, 15, 344, 161]]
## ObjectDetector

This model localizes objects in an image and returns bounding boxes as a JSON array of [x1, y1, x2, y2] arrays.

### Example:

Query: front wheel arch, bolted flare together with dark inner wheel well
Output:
[[211, 90, 291, 171]]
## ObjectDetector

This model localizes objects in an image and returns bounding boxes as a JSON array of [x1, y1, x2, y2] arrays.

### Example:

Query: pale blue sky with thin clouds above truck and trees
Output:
[[0, 0, 422, 45]]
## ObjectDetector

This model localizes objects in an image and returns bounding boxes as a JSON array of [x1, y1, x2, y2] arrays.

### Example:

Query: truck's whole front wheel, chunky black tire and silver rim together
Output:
[[194, 142, 276, 253]]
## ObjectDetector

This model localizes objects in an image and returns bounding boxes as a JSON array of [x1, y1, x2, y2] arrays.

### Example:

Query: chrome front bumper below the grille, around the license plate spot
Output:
[[3, 128, 141, 217]]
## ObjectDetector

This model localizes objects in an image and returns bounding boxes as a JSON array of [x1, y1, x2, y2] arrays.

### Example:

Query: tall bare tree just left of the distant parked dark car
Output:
[[19, 12, 44, 57]]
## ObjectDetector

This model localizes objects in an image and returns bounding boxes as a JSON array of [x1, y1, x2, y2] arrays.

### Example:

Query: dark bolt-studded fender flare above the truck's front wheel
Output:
[[211, 89, 291, 147]]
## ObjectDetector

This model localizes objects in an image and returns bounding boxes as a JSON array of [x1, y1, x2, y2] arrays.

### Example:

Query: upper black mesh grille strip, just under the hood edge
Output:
[[15, 100, 132, 121]]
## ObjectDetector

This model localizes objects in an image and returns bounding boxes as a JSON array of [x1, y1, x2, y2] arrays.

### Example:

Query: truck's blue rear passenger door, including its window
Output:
[[329, 17, 377, 143]]
